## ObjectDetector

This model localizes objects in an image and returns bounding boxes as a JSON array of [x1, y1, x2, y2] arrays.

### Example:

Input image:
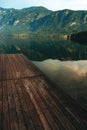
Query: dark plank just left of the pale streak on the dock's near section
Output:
[[19, 81, 43, 130]]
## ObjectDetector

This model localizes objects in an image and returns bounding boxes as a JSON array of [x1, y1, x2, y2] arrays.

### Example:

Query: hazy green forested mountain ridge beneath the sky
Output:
[[0, 7, 87, 34]]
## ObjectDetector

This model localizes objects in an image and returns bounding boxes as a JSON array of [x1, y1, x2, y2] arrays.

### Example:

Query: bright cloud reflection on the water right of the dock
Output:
[[35, 59, 87, 79]]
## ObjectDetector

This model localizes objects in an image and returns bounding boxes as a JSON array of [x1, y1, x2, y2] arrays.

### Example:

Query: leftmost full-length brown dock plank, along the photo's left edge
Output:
[[2, 55, 10, 130]]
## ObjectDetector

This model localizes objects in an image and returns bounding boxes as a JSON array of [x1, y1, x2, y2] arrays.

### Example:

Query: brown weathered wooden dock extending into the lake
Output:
[[0, 54, 87, 130]]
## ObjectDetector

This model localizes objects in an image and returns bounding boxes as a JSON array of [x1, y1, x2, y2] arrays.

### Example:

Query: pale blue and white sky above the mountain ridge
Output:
[[0, 0, 87, 11]]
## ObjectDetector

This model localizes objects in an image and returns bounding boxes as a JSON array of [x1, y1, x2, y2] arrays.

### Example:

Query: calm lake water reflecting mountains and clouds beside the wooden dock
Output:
[[0, 36, 87, 110]]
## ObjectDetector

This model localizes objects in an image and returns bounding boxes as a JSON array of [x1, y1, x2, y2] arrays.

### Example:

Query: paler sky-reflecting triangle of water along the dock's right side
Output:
[[34, 59, 87, 109]]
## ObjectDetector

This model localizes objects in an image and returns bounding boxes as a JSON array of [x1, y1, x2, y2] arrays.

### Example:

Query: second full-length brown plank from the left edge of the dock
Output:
[[4, 55, 18, 130]]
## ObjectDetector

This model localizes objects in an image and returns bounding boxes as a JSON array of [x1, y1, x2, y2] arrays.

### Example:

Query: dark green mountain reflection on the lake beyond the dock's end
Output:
[[0, 36, 87, 60]]
